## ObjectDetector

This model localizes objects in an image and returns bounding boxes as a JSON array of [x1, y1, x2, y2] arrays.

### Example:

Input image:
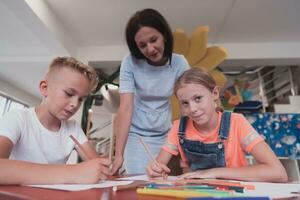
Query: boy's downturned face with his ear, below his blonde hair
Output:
[[40, 68, 91, 120]]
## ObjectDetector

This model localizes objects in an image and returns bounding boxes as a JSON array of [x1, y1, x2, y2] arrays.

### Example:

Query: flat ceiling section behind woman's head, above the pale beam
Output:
[[47, 0, 300, 46]]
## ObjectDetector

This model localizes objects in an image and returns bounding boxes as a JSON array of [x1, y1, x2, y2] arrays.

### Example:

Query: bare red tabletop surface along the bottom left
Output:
[[0, 185, 179, 200]]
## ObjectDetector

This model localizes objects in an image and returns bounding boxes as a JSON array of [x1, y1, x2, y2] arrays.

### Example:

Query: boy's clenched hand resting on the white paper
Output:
[[72, 158, 111, 183]]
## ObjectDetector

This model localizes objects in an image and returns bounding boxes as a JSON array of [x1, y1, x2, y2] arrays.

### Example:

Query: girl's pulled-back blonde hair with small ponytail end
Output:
[[174, 68, 223, 111]]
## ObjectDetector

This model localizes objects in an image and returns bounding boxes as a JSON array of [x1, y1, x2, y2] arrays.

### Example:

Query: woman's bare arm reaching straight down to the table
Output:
[[111, 93, 134, 174]]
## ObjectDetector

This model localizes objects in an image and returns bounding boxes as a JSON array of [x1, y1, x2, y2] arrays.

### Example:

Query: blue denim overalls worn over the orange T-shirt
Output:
[[178, 112, 231, 171]]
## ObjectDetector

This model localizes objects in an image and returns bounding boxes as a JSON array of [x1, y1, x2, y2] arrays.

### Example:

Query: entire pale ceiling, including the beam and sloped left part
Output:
[[0, 0, 300, 103]]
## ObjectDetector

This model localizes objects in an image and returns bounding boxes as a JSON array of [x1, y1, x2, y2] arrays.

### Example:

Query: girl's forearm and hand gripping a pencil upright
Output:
[[146, 149, 173, 177]]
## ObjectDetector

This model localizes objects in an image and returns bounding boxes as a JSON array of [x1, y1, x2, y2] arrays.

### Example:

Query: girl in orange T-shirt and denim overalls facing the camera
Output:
[[147, 69, 287, 182]]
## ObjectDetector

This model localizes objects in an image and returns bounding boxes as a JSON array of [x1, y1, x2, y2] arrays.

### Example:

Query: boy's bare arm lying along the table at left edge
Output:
[[0, 136, 109, 184]]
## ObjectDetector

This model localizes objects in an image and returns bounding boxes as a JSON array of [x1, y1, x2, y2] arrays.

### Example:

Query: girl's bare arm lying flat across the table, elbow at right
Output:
[[181, 142, 288, 182]]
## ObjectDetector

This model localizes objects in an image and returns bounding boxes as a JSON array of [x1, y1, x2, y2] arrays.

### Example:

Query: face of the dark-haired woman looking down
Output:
[[134, 26, 165, 65]]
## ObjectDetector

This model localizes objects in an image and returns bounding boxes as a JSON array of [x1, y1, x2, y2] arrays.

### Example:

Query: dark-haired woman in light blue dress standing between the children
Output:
[[111, 9, 189, 174]]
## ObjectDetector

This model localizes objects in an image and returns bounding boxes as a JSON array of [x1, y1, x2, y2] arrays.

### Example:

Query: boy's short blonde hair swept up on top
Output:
[[47, 56, 99, 91]]
